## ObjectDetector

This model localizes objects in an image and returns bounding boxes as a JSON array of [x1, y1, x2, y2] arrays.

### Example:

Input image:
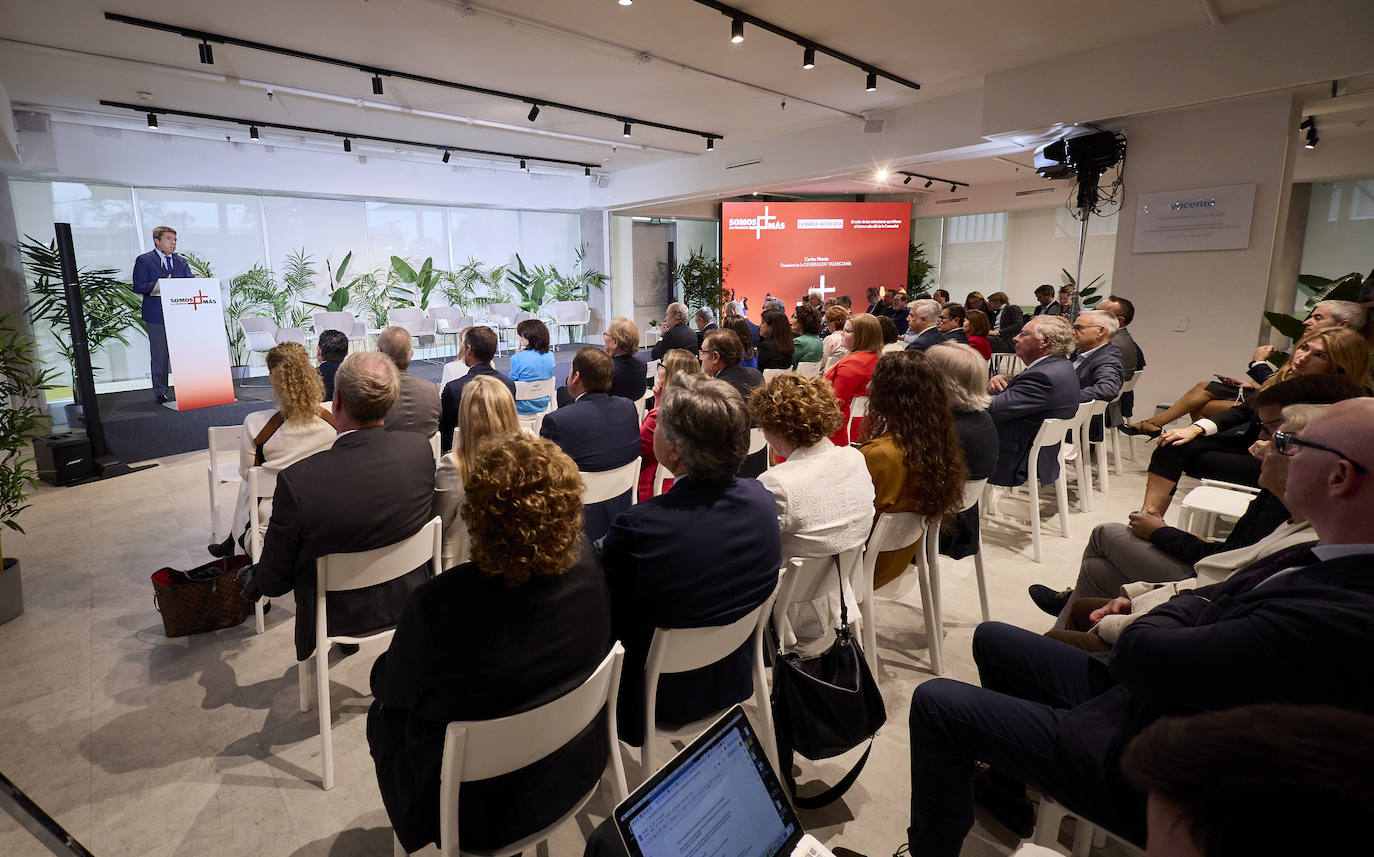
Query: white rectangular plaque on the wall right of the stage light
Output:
[[1131, 184, 1254, 253]]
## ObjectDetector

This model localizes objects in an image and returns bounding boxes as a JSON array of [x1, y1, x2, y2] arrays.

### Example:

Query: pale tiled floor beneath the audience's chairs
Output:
[[0, 445, 1172, 857]]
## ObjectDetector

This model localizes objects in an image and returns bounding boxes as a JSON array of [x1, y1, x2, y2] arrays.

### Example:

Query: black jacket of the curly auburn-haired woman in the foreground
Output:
[[367, 545, 611, 852]]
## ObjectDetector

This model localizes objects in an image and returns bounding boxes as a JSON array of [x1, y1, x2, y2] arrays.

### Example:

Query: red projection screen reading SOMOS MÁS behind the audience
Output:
[[720, 202, 911, 314]]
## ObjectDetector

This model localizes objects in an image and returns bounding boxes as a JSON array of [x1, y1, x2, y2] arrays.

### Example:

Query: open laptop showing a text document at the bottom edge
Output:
[[614, 705, 834, 857]]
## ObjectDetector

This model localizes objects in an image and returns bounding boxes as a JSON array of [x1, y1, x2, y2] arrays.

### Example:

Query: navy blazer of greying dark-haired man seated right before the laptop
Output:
[[602, 477, 782, 746]]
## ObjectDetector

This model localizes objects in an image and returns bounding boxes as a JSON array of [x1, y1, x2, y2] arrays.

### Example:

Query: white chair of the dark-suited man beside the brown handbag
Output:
[[295, 516, 442, 791]]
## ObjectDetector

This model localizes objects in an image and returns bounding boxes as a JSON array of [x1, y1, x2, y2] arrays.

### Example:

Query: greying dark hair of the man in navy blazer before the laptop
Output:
[[657, 373, 749, 479]]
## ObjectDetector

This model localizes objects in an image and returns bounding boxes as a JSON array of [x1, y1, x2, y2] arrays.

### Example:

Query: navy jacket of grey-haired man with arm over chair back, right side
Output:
[[988, 356, 1079, 485]]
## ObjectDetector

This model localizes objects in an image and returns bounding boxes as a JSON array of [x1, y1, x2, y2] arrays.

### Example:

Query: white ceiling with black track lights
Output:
[[0, 0, 1278, 174]]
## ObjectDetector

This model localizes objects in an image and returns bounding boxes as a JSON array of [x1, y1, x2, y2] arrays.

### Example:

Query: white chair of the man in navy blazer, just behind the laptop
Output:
[[639, 586, 778, 780]]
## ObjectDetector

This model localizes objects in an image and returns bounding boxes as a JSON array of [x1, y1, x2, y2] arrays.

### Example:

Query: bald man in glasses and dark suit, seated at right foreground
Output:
[[908, 398, 1374, 857]]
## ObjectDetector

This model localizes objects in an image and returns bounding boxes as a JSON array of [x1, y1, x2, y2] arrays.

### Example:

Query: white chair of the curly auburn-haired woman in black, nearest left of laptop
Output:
[[396, 643, 629, 857]]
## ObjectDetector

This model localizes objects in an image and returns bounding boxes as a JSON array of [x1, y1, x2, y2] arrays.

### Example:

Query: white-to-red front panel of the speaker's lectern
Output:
[[158, 277, 234, 411]]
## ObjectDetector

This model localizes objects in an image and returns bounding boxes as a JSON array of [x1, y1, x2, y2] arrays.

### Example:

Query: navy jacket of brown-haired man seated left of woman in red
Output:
[[539, 393, 640, 541]]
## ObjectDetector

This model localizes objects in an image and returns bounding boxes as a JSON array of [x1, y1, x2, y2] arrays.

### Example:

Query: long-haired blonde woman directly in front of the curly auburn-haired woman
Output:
[[433, 376, 519, 569]]
